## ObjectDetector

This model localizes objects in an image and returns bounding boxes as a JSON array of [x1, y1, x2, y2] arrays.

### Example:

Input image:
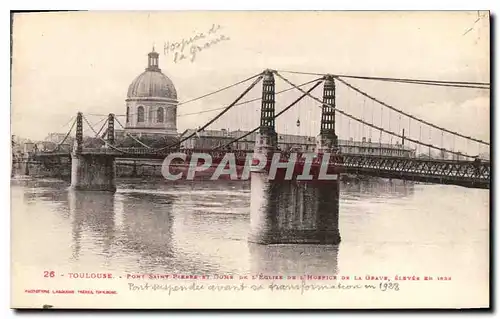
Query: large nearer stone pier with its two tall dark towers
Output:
[[248, 71, 340, 245]]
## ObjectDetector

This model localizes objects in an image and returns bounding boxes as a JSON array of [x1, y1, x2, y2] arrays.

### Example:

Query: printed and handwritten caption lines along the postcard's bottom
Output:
[[24, 270, 451, 295]]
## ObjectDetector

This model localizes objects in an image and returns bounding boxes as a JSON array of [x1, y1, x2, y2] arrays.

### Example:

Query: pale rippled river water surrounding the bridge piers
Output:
[[11, 178, 489, 308]]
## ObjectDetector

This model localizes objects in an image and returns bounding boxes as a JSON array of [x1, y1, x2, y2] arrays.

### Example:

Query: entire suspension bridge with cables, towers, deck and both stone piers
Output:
[[17, 70, 491, 244]]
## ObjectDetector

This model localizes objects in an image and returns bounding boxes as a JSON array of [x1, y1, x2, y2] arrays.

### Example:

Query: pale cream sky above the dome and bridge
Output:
[[11, 11, 490, 156]]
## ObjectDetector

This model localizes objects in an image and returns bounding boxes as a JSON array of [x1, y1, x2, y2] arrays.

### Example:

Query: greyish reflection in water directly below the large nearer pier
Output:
[[248, 244, 339, 276]]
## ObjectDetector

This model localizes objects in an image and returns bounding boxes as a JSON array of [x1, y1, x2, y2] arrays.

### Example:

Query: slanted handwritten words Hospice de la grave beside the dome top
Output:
[[163, 24, 230, 63]]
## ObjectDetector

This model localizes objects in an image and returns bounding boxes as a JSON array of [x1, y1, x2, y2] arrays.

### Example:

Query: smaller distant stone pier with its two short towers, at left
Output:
[[71, 112, 116, 192]]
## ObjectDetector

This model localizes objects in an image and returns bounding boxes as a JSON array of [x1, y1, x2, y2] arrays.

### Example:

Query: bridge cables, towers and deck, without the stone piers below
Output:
[[26, 70, 490, 189]]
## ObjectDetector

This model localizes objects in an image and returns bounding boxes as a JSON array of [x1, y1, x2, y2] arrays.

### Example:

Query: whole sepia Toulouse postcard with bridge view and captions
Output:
[[11, 11, 491, 309]]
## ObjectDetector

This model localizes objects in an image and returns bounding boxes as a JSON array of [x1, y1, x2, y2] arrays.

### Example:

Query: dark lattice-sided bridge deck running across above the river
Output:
[[32, 148, 491, 189]]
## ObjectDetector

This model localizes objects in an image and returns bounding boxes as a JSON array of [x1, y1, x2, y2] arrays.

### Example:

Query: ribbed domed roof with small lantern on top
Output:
[[127, 51, 177, 100]]
